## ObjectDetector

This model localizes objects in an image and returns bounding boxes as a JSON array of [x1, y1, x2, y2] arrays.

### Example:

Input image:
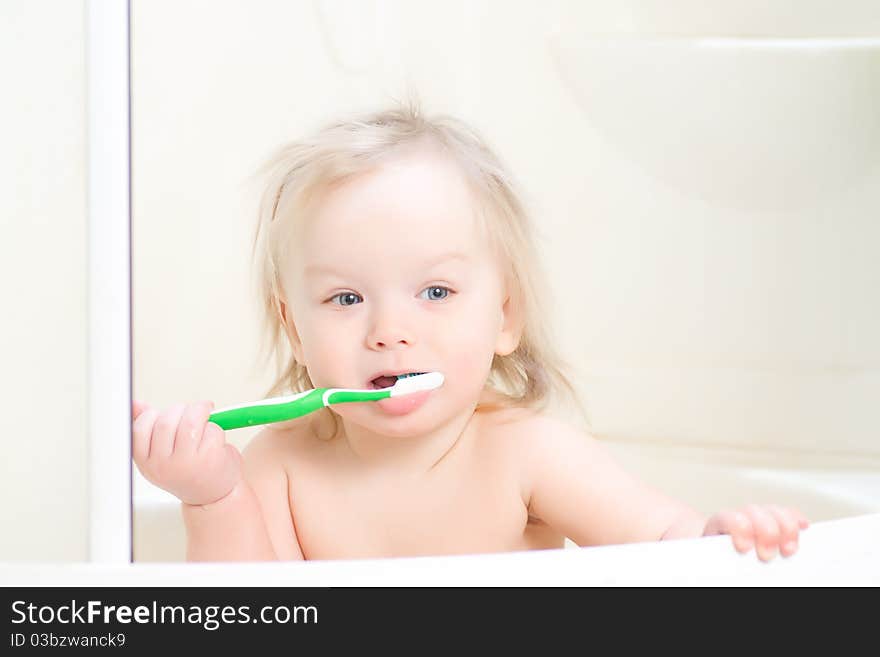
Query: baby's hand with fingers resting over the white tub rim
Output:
[[703, 504, 810, 561]]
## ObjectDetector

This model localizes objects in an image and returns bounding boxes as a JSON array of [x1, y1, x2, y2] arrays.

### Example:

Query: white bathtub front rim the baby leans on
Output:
[[12, 514, 880, 586]]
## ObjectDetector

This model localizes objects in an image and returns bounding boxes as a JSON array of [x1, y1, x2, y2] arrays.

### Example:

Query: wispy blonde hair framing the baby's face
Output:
[[253, 103, 589, 435]]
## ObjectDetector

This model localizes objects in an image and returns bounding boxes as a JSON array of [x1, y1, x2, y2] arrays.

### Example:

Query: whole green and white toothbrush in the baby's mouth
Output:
[[208, 372, 443, 429]]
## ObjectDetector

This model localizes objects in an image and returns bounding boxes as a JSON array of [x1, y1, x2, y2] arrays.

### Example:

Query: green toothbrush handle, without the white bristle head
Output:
[[208, 388, 391, 430]]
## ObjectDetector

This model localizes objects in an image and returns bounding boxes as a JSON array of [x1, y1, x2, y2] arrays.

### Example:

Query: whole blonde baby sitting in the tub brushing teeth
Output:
[[132, 101, 808, 561]]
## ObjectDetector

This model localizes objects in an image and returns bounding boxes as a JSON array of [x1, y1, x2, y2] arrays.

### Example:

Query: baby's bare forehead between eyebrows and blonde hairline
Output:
[[278, 148, 500, 272]]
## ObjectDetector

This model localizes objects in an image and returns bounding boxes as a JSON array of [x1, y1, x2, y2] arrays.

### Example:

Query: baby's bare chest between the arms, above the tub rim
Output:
[[291, 464, 528, 559]]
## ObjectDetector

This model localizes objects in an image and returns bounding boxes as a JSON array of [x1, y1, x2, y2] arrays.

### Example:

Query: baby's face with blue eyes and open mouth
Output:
[[283, 154, 516, 435]]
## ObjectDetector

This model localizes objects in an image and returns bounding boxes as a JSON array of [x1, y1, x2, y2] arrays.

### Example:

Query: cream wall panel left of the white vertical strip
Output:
[[0, 0, 88, 561]]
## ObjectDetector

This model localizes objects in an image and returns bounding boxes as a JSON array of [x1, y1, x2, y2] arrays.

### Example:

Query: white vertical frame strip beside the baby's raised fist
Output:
[[86, 0, 131, 564]]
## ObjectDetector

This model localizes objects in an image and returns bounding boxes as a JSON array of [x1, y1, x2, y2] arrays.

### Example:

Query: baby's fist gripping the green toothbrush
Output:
[[132, 402, 241, 505]]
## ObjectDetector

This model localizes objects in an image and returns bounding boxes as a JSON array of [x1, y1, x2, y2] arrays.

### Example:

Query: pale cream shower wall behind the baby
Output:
[[132, 0, 880, 512]]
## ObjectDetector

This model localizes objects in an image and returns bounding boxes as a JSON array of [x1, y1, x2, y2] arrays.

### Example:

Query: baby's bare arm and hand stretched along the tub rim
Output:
[[523, 417, 807, 561]]
